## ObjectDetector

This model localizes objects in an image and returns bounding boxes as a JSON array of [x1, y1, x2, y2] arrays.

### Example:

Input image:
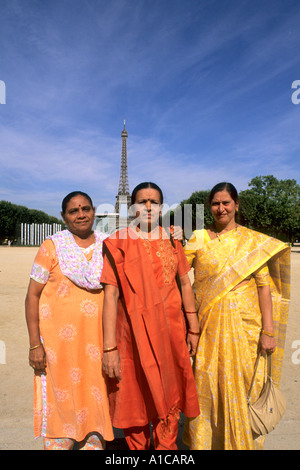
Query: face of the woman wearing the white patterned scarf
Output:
[[61, 195, 95, 237]]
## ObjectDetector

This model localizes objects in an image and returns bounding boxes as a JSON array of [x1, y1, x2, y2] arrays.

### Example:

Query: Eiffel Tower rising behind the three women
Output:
[[115, 120, 130, 218]]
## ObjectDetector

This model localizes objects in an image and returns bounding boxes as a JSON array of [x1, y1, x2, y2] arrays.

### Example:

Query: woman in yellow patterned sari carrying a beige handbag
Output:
[[184, 183, 289, 450]]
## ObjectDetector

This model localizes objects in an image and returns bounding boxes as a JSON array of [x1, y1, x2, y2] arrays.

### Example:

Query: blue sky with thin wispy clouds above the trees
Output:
[[0, 0, 300, 217]]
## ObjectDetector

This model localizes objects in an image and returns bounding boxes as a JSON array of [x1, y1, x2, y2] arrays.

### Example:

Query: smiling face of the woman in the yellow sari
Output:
[[210, 190, 239, 226]]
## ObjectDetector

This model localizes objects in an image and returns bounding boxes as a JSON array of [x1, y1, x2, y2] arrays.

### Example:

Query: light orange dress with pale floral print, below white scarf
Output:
[[31, 239, 114, 442]]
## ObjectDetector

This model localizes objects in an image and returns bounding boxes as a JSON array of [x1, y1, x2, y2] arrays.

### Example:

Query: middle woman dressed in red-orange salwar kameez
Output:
[[101, 183, 199, 450]]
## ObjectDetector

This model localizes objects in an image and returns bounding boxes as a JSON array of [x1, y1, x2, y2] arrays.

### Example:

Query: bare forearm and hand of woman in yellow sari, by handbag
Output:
[[257, 285, 276, 354]]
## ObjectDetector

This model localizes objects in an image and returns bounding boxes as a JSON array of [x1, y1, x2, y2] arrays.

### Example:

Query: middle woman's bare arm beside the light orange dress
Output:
[[102, 284, 121, 380]]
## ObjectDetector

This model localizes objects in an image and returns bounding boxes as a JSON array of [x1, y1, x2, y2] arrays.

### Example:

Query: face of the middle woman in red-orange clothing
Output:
[[134, 188, 161, 229]]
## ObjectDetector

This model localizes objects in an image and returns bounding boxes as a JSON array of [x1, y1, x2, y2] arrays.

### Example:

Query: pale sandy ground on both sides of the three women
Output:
[[0, 246, 300, 450]]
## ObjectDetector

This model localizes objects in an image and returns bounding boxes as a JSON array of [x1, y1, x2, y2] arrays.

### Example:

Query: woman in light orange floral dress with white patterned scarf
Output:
[[26, 191, 114, 450]]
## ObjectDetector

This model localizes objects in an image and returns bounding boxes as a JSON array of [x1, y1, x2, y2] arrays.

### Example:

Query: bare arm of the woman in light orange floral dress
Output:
[[25, 279, 46, 371]]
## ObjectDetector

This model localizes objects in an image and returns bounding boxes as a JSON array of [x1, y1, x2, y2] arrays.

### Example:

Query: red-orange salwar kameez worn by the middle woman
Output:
[[101, 228, 199, 448]]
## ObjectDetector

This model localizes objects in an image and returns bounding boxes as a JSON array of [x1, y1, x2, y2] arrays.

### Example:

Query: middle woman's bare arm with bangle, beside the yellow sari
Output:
[[180, 274, 200, 356]]
